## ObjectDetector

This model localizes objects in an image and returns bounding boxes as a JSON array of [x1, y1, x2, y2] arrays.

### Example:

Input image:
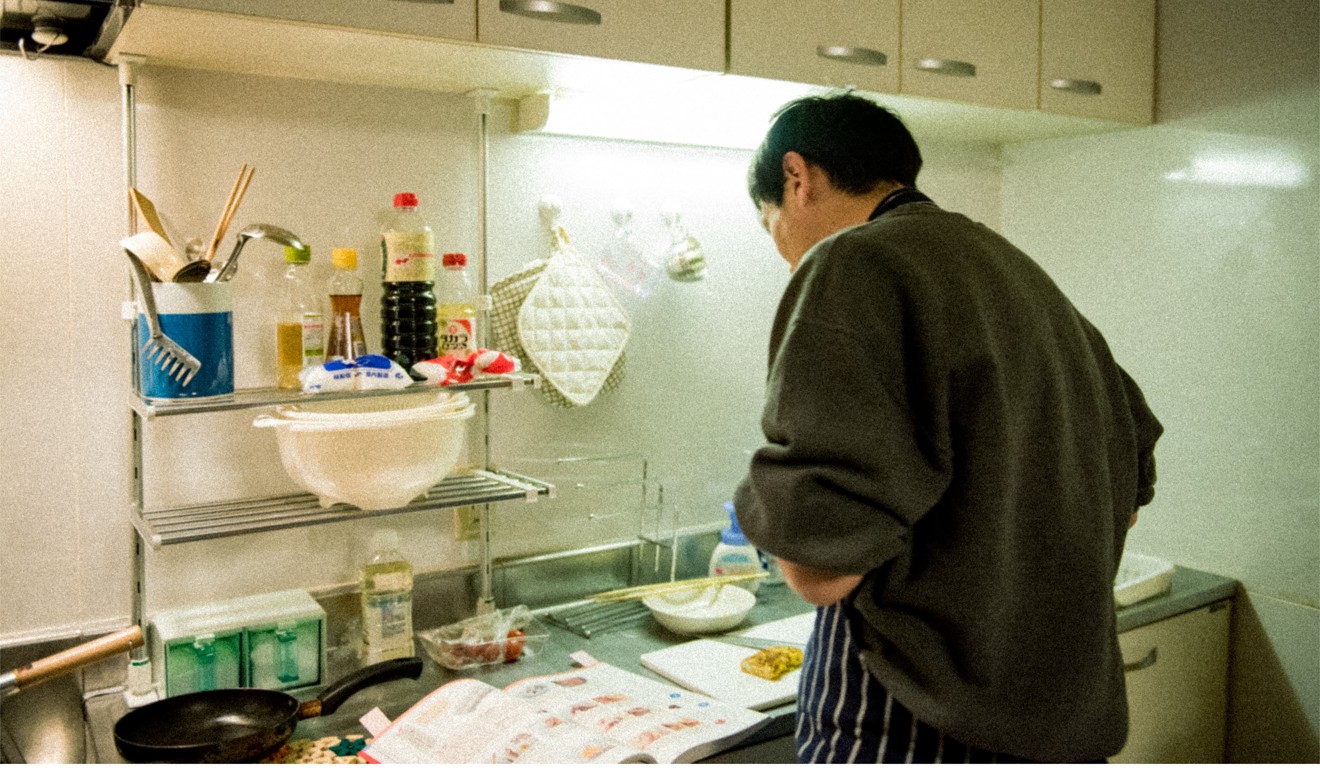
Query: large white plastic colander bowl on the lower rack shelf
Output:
[[252, 399, 475, 511]]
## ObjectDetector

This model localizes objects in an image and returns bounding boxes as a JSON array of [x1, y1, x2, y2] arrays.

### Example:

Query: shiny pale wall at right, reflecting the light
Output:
[[1003, 0, 1320, 762]]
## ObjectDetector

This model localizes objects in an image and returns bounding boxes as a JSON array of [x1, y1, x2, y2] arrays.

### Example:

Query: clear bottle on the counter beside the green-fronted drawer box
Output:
[[360, 530, 413, 664]]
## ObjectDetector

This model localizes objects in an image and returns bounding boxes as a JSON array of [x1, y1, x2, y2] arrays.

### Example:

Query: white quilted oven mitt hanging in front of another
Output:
[[517, 226, 631, 407]]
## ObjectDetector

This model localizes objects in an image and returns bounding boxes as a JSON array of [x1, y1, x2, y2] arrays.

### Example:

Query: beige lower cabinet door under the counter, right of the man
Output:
[[1111, 601, 1233, 763]]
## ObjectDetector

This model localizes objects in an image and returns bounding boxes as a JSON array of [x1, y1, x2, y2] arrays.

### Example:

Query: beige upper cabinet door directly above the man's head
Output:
[[729, 0, 899, 94]]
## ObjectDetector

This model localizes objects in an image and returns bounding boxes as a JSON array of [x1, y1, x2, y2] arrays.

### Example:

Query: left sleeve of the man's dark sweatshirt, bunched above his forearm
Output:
[[735, 245, 949, 575]]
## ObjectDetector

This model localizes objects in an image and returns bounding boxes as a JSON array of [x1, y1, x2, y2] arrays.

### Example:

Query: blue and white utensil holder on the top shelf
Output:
[[136, 283, 234, 400]]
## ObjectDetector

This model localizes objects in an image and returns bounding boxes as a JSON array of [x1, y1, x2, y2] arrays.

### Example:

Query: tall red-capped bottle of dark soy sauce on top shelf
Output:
[[380, 193, 436, 379]]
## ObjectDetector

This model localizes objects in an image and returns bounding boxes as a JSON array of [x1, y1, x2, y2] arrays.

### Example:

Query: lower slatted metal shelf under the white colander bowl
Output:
[[132, 469, 556, 548]]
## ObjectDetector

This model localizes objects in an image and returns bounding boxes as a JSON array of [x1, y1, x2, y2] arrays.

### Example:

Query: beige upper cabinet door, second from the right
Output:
[[900, 0, 1034, 110]]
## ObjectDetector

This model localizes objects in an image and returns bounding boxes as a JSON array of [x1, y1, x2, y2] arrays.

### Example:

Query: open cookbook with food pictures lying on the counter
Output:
[[360, 663, 770, 765]]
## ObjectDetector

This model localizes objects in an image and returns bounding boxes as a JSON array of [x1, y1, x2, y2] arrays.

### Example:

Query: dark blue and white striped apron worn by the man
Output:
[[796, 604, 1024, 765]]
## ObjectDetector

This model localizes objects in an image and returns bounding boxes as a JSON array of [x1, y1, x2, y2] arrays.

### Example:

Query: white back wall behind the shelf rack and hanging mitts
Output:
[[0, 57, 999, 645]]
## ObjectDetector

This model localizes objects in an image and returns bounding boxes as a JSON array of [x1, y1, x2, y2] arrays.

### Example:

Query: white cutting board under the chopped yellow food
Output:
[[642, 612, 816, 709]]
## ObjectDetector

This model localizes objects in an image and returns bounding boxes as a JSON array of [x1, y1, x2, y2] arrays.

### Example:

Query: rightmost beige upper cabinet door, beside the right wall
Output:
[[1040, 0, 1155, 124]]
